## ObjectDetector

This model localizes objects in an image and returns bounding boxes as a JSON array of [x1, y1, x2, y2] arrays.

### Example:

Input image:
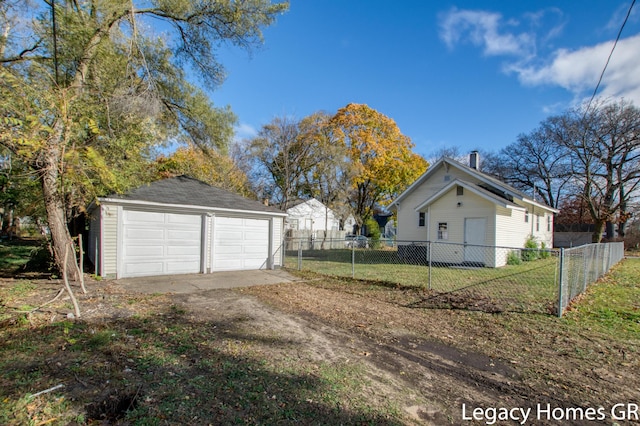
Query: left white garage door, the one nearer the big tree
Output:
[[118, 210, 202, 277]]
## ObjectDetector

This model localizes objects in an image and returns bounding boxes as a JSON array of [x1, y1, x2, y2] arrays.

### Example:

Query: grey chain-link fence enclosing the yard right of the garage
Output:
[[284, 238, 624, 314]]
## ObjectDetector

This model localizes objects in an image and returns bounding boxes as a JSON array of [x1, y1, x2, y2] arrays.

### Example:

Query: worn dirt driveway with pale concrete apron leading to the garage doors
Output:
[[115, 271, 556, 425]]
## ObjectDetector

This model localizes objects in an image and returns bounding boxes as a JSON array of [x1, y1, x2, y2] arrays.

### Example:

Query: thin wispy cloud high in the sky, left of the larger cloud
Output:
[[439, 8, 535, 56]]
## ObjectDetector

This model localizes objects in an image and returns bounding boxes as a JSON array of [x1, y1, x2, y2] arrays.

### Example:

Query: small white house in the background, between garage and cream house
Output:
[[285, 198, 340, 232]]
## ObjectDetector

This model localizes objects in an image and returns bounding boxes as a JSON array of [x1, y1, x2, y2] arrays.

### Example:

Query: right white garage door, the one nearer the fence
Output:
[[212, 216, 269, 271]]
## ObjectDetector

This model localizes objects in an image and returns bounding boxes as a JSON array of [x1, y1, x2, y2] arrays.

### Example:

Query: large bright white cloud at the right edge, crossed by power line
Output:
[[507, 34, 640, 104]]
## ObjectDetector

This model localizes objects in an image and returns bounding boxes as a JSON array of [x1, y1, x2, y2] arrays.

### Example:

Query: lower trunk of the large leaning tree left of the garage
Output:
[[40, 135, 79, 281]]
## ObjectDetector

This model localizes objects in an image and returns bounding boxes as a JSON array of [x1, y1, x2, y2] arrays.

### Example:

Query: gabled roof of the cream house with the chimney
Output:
[[391, 157, 558, 213]]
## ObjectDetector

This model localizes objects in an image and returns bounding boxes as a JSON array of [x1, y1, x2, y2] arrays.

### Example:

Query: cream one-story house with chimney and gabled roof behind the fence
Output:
[[391, 152, 558, 267]]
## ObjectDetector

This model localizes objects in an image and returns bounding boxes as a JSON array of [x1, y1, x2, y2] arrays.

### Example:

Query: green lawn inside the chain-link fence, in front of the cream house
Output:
[[285, 250, 558, 313]]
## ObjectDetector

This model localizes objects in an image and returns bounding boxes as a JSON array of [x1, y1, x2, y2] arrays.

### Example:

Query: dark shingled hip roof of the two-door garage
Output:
[[99, 176, 286, 216]]
